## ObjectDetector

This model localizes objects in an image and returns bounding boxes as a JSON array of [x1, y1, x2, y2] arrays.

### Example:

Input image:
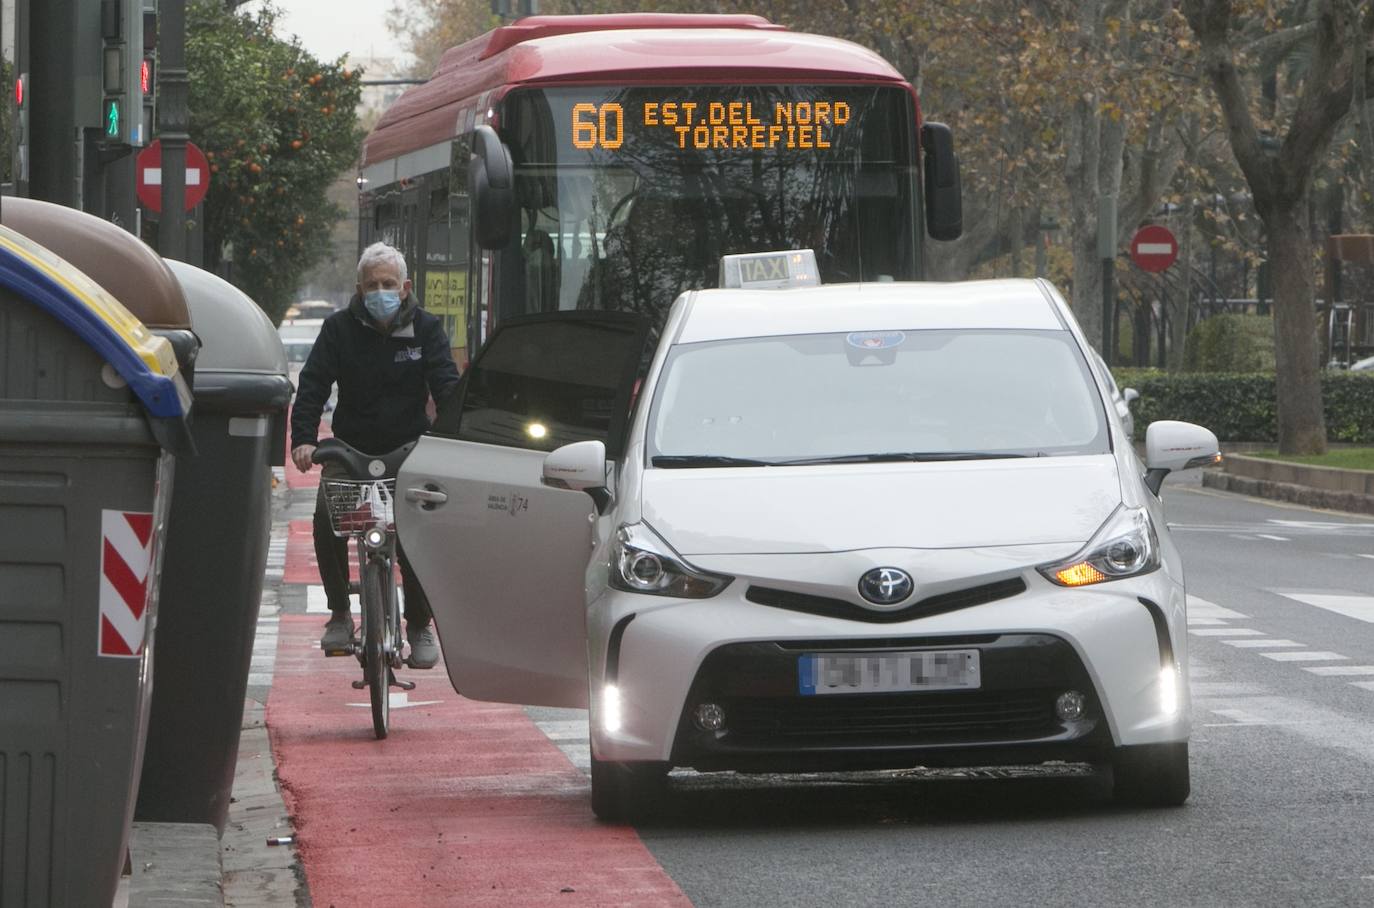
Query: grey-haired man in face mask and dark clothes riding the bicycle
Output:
[[291, 243, 458, 669]]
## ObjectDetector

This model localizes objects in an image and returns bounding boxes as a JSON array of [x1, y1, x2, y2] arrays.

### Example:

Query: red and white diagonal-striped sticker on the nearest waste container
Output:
[[100, 511, 153, 657]]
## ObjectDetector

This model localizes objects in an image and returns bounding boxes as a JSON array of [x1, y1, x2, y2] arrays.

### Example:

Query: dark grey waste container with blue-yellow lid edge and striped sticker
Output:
[[0, 227, 191, 908]]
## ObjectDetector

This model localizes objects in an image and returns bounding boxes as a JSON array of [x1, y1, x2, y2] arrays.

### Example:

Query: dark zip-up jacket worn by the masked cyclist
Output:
[[291, 294, 458, 455]]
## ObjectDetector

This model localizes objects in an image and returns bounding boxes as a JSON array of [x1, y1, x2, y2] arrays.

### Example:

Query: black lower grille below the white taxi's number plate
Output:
[[725, 690, 1062, 746]]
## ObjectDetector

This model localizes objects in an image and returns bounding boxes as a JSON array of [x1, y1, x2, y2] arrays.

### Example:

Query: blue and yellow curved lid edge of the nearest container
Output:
[[0, 226, 191, 428]]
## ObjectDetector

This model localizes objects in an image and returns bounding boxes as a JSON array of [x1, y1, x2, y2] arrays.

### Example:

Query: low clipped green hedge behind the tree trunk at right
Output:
[[1112, 368, 1374, 445]]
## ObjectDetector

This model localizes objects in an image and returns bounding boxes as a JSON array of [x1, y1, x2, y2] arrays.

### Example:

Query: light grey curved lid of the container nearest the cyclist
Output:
[[169, 256, 287, 375]]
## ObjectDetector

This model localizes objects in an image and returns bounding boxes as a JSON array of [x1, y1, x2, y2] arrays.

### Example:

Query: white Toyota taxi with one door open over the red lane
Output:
[[397, 263, 1220, 819]]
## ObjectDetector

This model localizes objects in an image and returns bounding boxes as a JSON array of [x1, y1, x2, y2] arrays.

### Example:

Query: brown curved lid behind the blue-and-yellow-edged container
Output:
[[0, 198, 191, 330]]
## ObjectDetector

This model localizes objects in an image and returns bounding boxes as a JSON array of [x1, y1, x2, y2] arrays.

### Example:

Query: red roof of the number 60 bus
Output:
[[363, 12, 905, 168]]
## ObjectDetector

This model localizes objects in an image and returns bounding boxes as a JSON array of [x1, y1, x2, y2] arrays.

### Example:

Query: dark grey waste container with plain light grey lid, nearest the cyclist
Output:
[[136, 261, 291, 832]]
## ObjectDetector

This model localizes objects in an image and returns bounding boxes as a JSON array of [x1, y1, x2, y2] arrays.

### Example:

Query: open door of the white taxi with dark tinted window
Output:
[[396, 310, 647, 706]]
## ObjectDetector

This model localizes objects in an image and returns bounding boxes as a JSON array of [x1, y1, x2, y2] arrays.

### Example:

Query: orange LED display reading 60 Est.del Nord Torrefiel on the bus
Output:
[[572, 99, 852, 151]]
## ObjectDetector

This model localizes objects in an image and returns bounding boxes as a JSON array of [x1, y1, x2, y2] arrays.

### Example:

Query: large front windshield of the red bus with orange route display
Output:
[[496, 85, 921, 323]]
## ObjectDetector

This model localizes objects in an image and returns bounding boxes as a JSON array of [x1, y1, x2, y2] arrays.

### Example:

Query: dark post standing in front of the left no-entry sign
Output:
[[158, 0, 191, 261]]
